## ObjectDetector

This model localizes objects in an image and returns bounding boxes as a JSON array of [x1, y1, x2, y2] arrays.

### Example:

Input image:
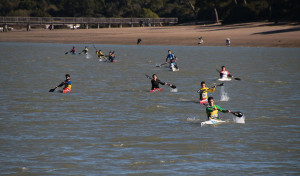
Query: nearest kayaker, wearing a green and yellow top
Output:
[[206, 97, 231, 120]]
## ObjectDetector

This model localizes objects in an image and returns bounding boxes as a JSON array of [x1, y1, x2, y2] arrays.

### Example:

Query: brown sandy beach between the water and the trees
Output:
[[0, 22, 300, 48]]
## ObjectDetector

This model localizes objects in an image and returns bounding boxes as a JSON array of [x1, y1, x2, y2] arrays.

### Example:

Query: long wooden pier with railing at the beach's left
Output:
[[0, 17, 178, 31]]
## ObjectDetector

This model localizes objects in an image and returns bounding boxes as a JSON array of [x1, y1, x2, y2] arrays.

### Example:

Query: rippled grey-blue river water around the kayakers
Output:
[[0, 43, 300, 176]]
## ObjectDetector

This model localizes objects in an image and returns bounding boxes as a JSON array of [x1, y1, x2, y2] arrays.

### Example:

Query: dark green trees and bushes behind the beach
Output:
[[0, 0, 300, 23]]
